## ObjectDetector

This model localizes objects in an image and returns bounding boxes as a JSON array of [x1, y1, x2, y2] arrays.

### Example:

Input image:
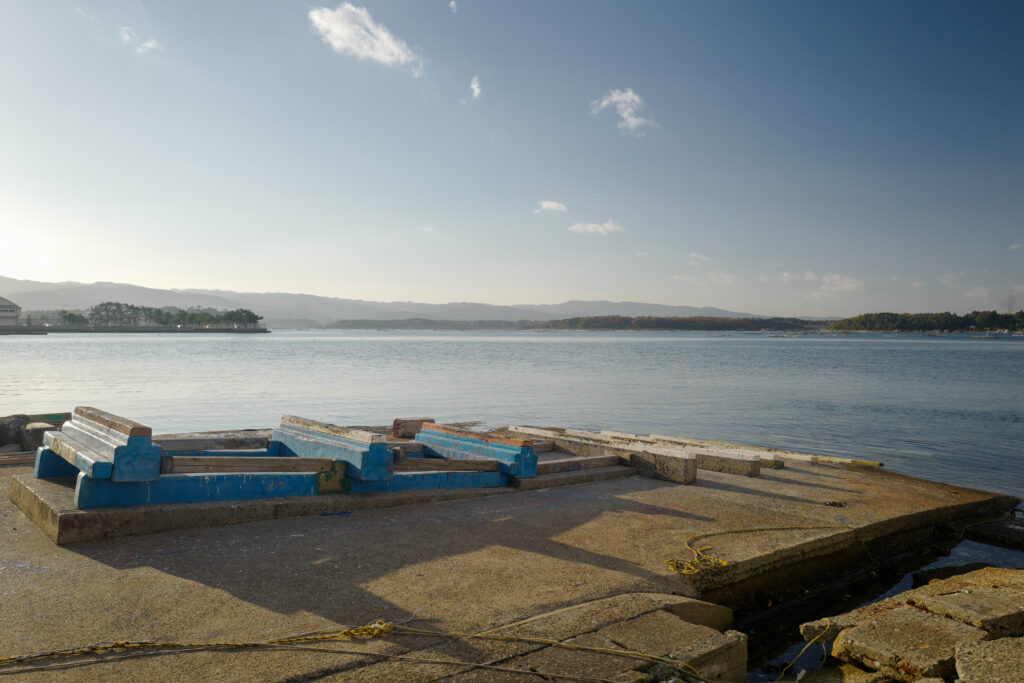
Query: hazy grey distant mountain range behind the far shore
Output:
[[0, 275, 758, 328]]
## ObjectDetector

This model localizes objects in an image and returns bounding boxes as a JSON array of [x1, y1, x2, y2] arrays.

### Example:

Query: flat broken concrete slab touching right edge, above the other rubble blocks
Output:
[[908, 588, 1024, 638]]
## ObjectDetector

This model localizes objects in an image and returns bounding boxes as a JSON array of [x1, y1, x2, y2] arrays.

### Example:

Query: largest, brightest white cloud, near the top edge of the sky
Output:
[[309, 2, 423, 78]]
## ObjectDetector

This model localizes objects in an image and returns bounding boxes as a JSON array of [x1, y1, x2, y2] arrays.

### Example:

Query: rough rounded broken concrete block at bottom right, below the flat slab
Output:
[[833, 607, 987, 681]]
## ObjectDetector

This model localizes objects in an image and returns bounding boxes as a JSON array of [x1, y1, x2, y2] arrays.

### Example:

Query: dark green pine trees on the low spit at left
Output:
[[57, 301, 263, 328]]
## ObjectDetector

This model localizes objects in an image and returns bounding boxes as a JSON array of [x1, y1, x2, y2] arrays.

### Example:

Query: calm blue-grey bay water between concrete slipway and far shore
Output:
[[0, 331, 1024, 495]]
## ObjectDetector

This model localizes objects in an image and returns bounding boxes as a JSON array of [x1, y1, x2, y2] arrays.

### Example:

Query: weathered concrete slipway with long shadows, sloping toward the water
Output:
[[0, 440, 1018, 681]]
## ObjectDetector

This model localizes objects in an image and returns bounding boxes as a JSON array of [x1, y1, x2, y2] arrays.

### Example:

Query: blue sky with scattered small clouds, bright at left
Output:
[[0, 0, 1024, 315]]
